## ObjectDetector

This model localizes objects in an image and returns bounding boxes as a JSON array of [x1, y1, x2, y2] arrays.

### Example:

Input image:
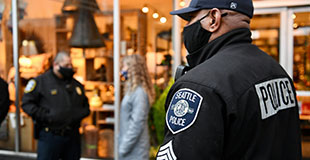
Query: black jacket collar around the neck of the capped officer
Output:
[[186, 28, 252, 68]]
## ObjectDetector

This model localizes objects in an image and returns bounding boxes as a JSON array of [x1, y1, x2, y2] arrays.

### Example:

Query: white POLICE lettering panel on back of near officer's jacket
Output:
[[255, 78, 296, 119]]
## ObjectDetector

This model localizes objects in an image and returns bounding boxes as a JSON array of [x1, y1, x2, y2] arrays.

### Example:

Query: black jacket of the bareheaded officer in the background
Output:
[[22, 69, 90, 129]]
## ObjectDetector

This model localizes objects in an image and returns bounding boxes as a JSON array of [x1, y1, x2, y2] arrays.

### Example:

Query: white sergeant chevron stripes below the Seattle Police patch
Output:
[[156, 140, 177, 160]]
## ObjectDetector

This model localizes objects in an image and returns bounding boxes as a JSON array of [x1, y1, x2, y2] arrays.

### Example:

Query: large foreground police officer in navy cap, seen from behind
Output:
[[157, 0, 301, 160]]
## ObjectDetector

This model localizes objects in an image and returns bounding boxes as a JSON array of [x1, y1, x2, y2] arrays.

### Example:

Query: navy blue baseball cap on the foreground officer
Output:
[[170, 0, 254, 21]]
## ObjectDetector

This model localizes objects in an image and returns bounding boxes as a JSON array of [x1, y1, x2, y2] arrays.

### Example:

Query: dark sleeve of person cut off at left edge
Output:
[[0, 78, 10, 124]]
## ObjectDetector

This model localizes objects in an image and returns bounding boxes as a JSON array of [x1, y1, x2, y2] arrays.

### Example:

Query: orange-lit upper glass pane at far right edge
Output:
[[293, 12, 310, 91]]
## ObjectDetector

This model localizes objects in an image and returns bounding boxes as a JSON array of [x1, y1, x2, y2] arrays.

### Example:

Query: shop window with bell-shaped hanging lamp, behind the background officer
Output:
[[0, 0, 114, 158]]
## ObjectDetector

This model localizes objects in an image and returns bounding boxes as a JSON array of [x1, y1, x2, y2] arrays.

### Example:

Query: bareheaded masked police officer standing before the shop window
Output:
[[22, 52, 90, 160]]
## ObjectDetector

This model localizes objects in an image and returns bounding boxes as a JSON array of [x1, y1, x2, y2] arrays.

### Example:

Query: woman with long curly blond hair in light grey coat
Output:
[[118, 55, 155, 160]]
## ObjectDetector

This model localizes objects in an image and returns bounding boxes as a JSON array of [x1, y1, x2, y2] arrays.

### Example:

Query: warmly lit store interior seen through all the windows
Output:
[[0, 0, 310, 158]]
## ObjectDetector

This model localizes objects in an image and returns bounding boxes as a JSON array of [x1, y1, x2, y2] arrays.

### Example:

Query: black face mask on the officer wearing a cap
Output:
[[183, 12, 212, 54]]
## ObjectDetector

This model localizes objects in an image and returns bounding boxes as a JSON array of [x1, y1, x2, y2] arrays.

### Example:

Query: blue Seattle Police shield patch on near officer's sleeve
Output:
[[166, 88, 203, 134]]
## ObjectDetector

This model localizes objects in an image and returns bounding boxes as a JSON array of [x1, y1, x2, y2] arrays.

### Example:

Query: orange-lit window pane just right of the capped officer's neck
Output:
[[251, 14, 280, 62]]
